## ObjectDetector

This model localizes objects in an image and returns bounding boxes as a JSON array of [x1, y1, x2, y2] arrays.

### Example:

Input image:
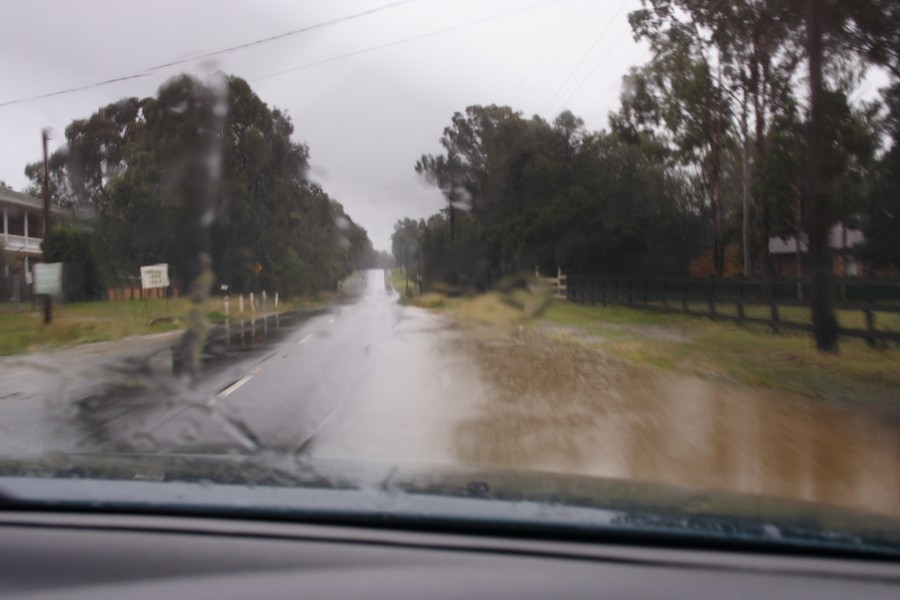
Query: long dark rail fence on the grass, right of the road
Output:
[[566, 275, 900, 346]]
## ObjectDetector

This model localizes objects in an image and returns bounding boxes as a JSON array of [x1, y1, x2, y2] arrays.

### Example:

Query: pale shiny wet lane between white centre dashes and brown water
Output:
[[223, 271, 486, 464]]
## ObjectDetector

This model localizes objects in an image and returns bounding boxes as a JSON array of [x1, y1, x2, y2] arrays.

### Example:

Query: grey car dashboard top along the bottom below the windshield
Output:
[[0, 510, 900, 600]]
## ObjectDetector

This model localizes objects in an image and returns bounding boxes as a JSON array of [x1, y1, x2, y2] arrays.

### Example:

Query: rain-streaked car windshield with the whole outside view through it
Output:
[[0, 0, 900, 547]]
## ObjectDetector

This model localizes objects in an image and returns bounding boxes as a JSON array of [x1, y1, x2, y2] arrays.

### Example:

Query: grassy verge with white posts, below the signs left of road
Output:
[[0, 296, 321, 356]]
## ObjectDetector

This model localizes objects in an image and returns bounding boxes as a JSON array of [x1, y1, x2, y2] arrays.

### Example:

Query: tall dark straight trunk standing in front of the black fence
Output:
[[806, 0, 838, 352]]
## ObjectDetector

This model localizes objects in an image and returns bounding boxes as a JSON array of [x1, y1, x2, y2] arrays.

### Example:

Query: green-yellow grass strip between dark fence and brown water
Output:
[[420, 290, 900, 403]]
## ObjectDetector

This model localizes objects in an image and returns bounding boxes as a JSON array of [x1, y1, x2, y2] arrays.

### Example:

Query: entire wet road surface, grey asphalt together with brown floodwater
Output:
[[0, 271, 900, 517]]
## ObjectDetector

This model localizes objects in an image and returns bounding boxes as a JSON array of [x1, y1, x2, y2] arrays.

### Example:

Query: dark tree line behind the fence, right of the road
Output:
[[394, 0, 900, 350]]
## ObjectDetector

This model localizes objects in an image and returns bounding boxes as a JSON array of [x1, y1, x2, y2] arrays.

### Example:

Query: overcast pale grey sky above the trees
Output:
[[0, 0, 648, 249]]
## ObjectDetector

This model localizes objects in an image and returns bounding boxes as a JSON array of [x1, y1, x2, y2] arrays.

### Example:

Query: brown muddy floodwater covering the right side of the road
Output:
[[455, 331, 900, 517]]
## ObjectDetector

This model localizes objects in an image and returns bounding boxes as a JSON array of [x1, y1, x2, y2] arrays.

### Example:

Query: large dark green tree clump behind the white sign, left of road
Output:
[[25, 73, 379, 295]]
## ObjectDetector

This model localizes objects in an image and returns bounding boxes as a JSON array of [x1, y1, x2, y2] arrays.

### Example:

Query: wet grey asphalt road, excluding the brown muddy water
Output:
[[0, 270, 476, 462]]
